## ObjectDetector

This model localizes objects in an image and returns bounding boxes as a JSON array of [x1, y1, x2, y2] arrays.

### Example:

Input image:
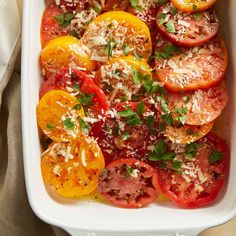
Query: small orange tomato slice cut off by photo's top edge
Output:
[[171, 0, 216, 12]]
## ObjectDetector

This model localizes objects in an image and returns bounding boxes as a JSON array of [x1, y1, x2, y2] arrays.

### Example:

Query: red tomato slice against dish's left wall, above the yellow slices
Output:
[[41, 5, 68, 47]]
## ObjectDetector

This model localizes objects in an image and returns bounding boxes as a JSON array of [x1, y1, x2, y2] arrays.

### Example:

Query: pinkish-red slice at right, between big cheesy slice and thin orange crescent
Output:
[[164, 82, 228, 125]]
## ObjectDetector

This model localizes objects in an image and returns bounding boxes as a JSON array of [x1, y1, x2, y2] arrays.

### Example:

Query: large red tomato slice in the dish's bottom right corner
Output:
[[158, 133, 229, 208]]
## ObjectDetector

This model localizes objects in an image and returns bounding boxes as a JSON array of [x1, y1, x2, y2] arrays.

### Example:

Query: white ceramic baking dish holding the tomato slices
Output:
[[22, 0, 236, 236]]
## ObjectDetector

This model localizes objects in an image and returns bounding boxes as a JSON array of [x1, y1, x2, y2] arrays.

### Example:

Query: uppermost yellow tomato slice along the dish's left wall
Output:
[[40, 36, 95, 78]]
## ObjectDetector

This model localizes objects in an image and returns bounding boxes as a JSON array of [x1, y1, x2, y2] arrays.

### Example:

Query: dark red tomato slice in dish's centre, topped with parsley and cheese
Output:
[[90, 102, 158, 164]]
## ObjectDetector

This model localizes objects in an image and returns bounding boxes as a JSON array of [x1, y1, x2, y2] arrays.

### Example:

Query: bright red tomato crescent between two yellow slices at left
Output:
[[39, 68, 108, 117]]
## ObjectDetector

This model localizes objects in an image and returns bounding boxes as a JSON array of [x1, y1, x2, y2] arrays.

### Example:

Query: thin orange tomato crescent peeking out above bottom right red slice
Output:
[[163, 122, 214, 144]]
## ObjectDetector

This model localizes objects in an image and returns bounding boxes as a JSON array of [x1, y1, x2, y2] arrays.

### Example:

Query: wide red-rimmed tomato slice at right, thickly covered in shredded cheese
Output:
[[156, 35, 228, 92]]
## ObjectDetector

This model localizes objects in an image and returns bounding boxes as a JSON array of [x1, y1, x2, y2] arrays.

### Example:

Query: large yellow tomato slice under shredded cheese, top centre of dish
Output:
[[82, 11, 152, 62]]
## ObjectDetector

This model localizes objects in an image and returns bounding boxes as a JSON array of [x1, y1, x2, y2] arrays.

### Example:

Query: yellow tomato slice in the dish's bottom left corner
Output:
[[41, 136, 105, 198]]
